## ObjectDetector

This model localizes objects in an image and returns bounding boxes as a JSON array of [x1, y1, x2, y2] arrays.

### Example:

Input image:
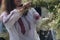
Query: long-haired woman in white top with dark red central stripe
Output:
[[0, 0, 40, 40]]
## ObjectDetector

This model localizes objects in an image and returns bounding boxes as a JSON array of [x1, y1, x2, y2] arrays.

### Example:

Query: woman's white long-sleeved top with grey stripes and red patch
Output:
[[0, 8, 40, 40]]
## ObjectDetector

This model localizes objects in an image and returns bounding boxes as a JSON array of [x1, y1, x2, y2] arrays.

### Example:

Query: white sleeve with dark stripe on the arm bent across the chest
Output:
[[3, 9, 22, 25]]
